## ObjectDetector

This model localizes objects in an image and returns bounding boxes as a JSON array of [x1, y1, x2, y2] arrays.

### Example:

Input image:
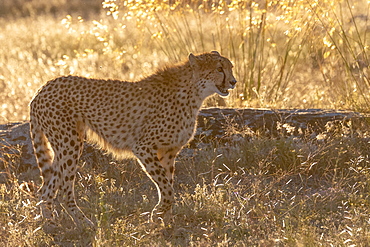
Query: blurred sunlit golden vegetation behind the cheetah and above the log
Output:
[[0, 0, 370, 122]]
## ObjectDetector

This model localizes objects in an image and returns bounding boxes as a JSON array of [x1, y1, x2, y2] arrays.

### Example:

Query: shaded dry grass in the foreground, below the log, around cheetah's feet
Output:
[[0, 126, 370, 246]]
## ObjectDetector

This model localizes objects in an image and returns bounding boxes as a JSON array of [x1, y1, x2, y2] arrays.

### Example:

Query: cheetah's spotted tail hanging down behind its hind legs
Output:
[[30, 114, 54, 180]]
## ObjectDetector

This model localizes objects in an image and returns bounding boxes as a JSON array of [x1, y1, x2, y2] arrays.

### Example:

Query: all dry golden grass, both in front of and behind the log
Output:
[[0, 0, 370, 246]]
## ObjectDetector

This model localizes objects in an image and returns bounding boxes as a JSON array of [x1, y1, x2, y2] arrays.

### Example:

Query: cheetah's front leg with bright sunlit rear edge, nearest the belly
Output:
[[133, 146, 174, 224]]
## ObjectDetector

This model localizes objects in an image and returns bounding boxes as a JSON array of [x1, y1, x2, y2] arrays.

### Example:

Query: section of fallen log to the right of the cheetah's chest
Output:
[[195, 108, 370, 140]]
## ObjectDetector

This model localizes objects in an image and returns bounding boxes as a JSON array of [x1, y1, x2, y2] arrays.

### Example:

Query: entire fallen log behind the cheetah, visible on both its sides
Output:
[[0, 108, 369, 171]]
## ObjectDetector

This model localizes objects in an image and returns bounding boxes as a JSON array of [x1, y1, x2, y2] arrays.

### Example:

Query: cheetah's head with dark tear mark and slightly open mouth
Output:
[[189, 51, 236, 97]]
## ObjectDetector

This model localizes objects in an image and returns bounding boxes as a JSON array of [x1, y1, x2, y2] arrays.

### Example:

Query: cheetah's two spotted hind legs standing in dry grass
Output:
[[35, 117, 95, 229]]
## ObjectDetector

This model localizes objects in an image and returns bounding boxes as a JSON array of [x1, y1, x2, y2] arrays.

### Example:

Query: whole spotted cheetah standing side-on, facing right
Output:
[[30, 51, 236, 227]]
